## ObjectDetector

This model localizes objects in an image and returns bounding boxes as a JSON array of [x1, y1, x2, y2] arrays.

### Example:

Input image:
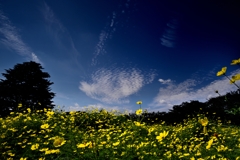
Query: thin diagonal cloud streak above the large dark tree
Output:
[[0, 11, 43, 65]]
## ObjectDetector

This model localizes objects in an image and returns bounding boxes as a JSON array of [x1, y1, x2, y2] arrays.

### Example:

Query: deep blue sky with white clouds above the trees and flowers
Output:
[[0, 0, 240, 112]]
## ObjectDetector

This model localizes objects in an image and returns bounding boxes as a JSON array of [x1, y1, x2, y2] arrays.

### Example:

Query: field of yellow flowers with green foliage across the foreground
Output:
[[0, 105, 240, 160]]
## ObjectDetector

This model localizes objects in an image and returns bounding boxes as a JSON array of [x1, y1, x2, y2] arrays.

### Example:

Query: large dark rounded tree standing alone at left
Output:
[[0, 61, 55, 117]]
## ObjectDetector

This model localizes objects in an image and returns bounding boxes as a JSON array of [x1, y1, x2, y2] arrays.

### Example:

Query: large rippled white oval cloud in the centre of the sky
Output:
[[79, 68, 155, 104]]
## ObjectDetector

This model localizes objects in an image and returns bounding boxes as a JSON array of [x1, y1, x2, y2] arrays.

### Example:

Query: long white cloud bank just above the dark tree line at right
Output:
[[149, 69, 240, 111]]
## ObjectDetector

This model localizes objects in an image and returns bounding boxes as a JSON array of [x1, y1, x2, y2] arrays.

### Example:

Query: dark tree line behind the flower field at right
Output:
[[127, 89, 240, 126]]
